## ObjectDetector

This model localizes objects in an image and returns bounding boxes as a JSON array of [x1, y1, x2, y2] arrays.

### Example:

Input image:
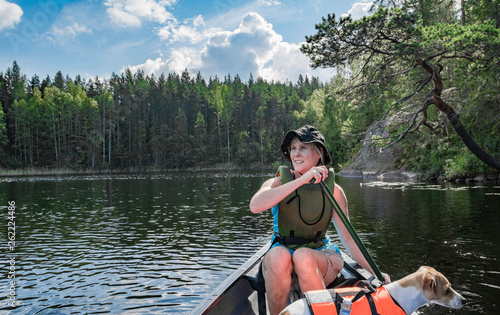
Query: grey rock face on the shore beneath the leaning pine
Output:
[[339, 116, 419, 180]]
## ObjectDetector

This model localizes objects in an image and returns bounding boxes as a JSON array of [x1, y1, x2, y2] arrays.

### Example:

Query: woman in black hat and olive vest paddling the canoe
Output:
[[250, 125, 373, 314]]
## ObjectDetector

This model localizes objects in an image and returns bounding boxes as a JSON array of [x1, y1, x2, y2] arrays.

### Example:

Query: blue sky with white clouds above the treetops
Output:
[[0, 0, 371, 83]]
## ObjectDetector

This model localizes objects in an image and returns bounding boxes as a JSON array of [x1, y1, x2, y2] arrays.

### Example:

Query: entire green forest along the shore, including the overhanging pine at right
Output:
[[0, 0, 500, 178]]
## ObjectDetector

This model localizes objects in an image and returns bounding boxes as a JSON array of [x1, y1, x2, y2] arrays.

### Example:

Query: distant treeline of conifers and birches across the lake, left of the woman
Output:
[[0, 61, 322, 170]]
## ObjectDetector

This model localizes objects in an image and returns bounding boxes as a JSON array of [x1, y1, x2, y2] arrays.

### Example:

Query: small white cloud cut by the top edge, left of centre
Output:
[[104, 0, 177, 27]]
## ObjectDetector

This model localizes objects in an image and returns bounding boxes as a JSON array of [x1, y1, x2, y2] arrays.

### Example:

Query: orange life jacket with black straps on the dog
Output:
[[304, 287, 406, 315]]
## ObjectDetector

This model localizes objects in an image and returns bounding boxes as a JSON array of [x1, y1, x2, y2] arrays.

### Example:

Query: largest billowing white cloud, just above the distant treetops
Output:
[[122, 12, 332, 82]]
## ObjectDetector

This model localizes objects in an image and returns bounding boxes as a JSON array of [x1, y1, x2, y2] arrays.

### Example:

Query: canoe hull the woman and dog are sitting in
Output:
[[190, 243, 382, 315]]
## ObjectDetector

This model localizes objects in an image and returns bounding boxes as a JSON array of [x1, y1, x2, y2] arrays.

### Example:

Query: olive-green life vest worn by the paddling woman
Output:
[[275, 166, 335, 250]]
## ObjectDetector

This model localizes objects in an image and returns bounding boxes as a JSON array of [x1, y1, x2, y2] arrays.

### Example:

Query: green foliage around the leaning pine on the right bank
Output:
[[301, 0, 500, 176]]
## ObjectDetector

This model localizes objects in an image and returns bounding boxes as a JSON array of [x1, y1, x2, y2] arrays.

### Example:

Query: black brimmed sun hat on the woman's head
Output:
[[281, 125, 332, 166]]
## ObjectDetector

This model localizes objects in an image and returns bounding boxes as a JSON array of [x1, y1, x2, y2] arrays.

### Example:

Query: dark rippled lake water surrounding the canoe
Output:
[[0, 172, 500, 314]]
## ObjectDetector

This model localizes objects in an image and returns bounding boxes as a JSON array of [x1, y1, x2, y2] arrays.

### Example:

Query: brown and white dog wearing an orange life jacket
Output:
[[280, 266, 467, 315]]
